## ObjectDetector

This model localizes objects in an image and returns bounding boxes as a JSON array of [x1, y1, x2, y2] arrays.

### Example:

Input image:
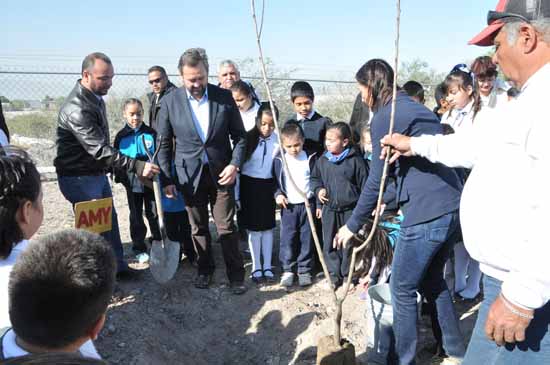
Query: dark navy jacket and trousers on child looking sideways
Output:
[[311, 148, 368, 282]]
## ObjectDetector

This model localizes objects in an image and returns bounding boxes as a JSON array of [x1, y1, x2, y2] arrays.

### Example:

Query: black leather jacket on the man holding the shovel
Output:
[[54, 80, 145, 176]]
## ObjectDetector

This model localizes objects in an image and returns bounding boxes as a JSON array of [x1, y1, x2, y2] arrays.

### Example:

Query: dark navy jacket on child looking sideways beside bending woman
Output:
[[311, 148, 368, 211]]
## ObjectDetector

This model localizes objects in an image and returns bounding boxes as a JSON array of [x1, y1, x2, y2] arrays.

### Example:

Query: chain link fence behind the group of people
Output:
[[0, 70, 357, 136]]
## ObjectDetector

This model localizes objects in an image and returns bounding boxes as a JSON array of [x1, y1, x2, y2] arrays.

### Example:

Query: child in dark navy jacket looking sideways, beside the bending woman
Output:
[[311, 122, 368, 286]]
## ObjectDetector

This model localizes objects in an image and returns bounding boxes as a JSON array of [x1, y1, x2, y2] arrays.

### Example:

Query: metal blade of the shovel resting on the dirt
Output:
[[149, 237, 180, 284]]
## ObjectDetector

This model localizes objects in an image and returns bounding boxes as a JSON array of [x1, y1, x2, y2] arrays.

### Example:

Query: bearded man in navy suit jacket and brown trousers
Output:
[[157, 48, 246, 294]]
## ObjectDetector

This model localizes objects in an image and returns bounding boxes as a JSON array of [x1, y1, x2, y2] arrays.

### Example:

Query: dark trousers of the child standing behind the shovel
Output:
[[126, 187, 162, 243]]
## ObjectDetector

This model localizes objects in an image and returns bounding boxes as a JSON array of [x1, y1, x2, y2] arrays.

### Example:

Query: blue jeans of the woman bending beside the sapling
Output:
[[390, 211, 466, 364]]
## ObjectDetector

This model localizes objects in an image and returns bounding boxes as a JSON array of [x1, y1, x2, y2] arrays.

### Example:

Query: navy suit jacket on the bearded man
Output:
[[158, 84, 246, 195]]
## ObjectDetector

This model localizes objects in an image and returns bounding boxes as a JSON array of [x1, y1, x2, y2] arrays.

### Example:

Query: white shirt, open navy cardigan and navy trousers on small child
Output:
[[273, 151, 316, 274]]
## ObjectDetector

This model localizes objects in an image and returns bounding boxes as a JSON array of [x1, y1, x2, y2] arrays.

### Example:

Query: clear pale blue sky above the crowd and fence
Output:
[[0, 0, 497, 80]]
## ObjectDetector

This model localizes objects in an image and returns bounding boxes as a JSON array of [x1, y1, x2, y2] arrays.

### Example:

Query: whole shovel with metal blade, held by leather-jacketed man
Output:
[[141, 136, 180, 284]]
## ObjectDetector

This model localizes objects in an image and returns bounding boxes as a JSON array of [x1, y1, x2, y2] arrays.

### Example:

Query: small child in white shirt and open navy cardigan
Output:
[[273, 123, 316, 287]]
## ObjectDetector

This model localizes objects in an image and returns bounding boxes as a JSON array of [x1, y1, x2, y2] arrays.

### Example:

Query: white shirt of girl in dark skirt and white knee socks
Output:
[[241, 133, 279, 179]]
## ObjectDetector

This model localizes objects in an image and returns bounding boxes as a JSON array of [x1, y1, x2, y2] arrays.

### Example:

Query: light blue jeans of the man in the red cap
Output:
[[462, 275, 550, 365]]
